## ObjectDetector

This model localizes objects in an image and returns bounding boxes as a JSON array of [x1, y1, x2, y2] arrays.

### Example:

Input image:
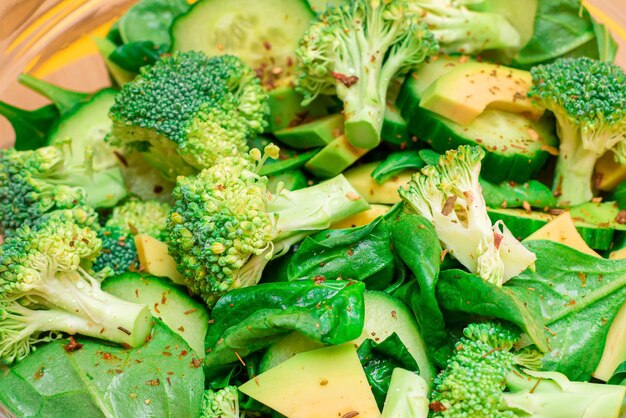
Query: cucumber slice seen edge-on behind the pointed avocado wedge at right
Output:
[[488, 209, 615, 250]]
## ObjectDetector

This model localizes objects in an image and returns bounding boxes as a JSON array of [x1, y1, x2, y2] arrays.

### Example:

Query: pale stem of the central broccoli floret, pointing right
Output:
[[268, 174, 369, 238]]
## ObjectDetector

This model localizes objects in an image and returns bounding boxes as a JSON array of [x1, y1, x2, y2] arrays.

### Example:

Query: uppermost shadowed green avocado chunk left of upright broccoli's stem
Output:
[[267, 86, 334, 132]]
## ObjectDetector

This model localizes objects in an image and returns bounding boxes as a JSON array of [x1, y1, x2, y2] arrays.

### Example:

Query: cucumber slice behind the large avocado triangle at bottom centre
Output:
[[260, 291, 435, 386]]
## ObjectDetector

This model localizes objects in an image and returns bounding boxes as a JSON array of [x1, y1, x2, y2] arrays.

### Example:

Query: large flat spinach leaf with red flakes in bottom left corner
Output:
[[0, 320, 204, 418]]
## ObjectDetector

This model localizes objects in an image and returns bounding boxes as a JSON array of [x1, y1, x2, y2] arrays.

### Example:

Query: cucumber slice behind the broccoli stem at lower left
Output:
[[102, 273, 209, 357]]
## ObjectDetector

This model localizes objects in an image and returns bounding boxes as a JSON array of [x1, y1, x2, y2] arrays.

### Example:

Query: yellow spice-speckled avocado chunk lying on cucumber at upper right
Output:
[[420, 62, 544, 125]]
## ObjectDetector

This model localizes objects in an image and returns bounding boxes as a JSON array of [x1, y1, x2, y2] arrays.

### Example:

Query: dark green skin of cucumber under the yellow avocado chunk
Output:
[[396, 76, 550, 183]]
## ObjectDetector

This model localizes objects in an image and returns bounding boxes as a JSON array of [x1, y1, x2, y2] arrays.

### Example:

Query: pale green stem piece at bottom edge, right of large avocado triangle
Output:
[[381, 367, 430, 418]]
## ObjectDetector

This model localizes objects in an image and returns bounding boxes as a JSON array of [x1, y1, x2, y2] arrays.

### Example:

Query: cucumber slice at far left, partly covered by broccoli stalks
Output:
[[49, 89, 117, 171]]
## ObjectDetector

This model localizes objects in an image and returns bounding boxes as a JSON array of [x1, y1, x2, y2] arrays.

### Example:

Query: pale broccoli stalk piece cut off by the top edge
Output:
[[408, 0, 523, 54]]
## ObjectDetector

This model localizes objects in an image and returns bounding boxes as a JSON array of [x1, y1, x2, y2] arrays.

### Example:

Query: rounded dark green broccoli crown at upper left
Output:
[[110, 51, 269, 180]]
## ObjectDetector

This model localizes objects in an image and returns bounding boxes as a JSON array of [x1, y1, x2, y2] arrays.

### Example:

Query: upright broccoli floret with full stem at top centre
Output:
[[296, 0, 438, 148]]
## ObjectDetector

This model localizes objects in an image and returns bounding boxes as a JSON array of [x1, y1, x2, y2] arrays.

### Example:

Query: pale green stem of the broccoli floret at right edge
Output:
[[553, 124, 600, 206]]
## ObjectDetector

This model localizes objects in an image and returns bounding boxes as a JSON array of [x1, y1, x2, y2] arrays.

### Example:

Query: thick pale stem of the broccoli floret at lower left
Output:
[[34, 269, 152, 347]]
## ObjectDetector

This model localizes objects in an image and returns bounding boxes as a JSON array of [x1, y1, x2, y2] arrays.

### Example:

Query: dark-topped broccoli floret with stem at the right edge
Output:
[[529, 57, 626, 206]]
